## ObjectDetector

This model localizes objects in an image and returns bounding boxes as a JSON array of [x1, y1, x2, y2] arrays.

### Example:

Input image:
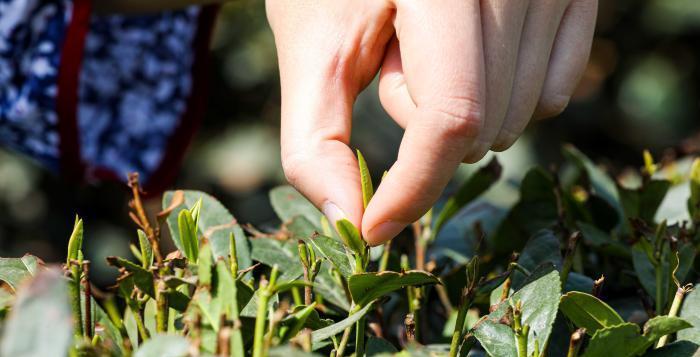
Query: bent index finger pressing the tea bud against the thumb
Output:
[[362, 0, 484, 245]]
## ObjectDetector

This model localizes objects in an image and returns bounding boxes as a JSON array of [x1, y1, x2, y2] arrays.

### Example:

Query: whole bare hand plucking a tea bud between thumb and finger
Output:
[[266, 0, 597, 245]]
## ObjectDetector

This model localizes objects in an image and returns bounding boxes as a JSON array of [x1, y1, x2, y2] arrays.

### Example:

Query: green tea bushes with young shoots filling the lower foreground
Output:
[[0, 147, 700, 357]]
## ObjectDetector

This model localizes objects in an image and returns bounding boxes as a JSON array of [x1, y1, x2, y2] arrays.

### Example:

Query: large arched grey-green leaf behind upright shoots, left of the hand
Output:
[[163, 190, 252, 269]]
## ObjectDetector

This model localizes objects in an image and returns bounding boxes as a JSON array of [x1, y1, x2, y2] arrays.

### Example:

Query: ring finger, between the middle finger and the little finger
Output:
[[492, 0, 568, 151]]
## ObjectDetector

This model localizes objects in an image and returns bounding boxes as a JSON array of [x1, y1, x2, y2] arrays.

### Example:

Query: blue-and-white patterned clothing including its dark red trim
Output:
[[0, 0, 215, 190]]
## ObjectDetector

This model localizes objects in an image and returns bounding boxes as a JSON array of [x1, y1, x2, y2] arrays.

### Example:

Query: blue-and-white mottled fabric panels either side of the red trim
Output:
[[0, 0, 200, 184]]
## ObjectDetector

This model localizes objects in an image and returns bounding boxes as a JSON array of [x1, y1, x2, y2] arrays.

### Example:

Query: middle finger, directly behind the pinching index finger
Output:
[[464, 0, 530, 163]]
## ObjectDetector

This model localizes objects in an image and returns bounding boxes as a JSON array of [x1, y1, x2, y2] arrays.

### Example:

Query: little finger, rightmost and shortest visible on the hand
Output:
[[535, 0, 598, 119]]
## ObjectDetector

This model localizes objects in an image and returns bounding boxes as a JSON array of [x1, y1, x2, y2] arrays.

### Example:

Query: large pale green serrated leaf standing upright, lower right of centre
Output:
[[475, 265, 561, 355]]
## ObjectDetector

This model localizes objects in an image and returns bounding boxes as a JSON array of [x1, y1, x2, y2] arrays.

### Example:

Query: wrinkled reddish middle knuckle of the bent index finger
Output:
[[429, 97, 484, 139]]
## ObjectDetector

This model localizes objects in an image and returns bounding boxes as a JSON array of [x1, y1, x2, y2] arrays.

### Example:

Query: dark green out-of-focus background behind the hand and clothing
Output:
[[0, 0, 700, 284]]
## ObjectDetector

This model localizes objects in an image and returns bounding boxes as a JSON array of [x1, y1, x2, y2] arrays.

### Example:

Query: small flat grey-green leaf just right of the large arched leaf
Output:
[[250, 238, 304, 281]]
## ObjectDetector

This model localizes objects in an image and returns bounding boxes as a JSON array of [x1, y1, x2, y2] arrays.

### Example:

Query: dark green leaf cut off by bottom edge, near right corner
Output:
[[583, 322, 647, 357]]
